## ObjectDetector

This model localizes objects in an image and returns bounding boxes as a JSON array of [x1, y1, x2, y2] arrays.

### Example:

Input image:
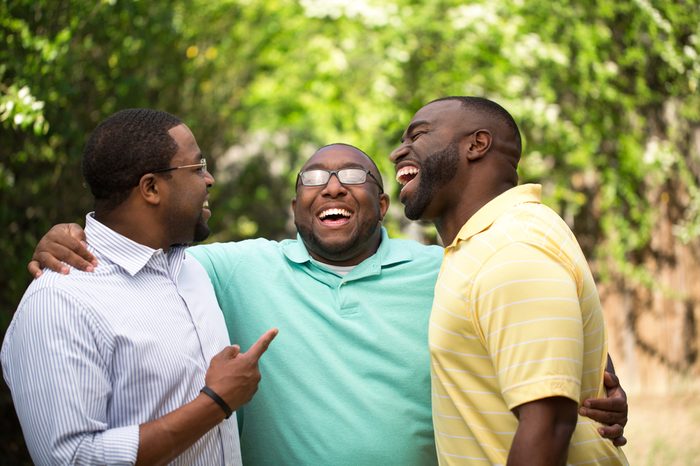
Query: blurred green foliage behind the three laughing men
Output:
[[0, 0, 700, 458]]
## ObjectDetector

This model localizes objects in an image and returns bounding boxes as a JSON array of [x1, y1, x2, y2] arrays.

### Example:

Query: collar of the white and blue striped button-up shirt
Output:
[[85, 212, 185, 276]]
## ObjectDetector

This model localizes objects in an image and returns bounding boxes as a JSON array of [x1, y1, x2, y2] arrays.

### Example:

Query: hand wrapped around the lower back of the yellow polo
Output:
[[579, 371, 628, 447]]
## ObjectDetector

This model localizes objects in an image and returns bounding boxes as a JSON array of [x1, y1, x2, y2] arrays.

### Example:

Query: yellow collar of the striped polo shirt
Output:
[[449, 184, 542, 248]]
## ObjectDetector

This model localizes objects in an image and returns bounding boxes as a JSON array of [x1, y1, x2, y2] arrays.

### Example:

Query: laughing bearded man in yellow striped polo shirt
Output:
[[391, 97, 627, 466]]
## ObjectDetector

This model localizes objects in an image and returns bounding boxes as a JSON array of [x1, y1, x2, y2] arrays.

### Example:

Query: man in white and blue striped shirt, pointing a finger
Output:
[[1, 109, 277, 466]]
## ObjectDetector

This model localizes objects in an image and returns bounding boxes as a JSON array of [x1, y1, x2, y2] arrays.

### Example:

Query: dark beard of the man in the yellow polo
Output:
[[404, 142, 459, 220]]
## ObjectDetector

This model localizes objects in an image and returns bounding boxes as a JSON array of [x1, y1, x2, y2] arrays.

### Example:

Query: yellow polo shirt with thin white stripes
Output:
[[429, 184, 627, 465]]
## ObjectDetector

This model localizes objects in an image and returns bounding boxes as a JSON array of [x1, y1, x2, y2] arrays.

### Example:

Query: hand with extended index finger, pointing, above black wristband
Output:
[[204, 328, 278, 411]]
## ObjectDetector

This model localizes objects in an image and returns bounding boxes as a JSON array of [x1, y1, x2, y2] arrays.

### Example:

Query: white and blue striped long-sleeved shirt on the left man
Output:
[[0, 214, 241, 465]]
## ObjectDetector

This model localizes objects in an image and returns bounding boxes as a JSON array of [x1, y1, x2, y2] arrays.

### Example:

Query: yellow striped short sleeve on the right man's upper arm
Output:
[[473, 243, 583, 409]]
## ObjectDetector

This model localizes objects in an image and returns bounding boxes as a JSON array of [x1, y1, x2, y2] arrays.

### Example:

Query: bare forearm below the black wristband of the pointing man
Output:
[[136, 394, 230, 465]]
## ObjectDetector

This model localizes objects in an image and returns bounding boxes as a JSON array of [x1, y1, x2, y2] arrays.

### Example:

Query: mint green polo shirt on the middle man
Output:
[[188, 229, 442, 466]]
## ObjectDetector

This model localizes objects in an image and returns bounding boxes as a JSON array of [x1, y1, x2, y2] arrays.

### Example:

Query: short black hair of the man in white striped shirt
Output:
[[82, 108, 182, 210]]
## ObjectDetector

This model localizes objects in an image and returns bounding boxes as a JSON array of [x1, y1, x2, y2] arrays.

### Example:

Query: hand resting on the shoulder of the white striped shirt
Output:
[[27, 223, 97, 278]]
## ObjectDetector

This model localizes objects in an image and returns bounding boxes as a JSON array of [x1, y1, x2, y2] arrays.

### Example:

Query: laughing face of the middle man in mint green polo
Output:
[[292, 144, 389, 265]]
